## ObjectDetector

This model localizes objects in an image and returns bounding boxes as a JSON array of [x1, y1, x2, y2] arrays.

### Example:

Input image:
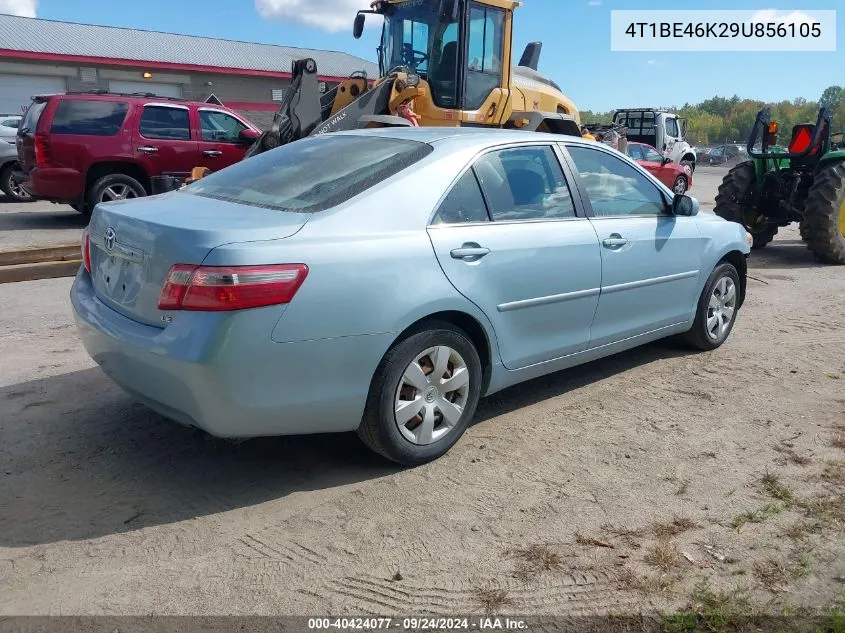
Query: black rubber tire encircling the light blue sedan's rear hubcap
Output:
[[358, 321, 483, 466]]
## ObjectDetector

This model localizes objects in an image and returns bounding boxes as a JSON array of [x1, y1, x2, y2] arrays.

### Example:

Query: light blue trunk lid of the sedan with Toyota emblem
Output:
[[89, 191, 309, 327]]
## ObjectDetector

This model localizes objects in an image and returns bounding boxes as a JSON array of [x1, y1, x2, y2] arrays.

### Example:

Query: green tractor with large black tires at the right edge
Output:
[[714, 108, 845, 264]]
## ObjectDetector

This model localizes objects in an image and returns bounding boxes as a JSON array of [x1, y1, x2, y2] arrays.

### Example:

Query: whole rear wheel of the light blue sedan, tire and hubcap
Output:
[[358, 322, 482, 466]]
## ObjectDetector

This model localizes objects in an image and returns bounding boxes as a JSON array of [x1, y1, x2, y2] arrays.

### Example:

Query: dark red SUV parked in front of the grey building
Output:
[[17, 92, 260, 213]]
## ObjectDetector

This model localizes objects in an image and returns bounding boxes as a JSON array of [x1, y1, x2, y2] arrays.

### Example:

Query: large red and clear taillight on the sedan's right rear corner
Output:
[[158, 264, 308, 312]]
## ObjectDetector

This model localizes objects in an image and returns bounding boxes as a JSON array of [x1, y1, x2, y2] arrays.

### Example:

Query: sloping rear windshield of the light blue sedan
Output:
[[185, 134, 433, 213]]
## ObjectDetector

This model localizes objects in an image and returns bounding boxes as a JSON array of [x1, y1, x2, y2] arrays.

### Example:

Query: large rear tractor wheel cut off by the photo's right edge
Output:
[[801, 162, 845, 265]]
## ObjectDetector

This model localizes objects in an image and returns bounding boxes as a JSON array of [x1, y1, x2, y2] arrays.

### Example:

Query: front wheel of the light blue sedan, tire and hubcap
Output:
[[683, 262, 740, 351]]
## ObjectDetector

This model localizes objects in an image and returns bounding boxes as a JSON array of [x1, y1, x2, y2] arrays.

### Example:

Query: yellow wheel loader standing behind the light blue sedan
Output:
[[186, 0, 581, 180]]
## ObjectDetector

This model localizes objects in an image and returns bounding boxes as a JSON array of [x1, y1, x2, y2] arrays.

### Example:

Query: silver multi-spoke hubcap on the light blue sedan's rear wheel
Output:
[[394, 345, 469, 446]]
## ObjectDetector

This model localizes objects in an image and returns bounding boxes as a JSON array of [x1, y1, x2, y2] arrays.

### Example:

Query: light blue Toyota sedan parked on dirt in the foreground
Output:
[[71, 128, 750, 464]]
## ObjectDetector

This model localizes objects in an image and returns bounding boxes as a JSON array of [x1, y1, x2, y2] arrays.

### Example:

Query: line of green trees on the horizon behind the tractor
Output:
[[581, 86, 845, 145]]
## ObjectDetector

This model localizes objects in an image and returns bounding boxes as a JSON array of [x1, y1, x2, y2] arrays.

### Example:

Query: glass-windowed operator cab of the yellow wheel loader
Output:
[[354, 0, 510, 111]]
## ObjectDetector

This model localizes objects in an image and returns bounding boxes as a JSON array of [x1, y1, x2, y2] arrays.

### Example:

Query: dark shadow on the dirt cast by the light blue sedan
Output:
[[0, 341, 689, 547]]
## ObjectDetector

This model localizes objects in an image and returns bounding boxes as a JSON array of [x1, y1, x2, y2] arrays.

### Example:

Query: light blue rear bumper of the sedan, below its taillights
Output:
[[71, 269, 392, 438]]
